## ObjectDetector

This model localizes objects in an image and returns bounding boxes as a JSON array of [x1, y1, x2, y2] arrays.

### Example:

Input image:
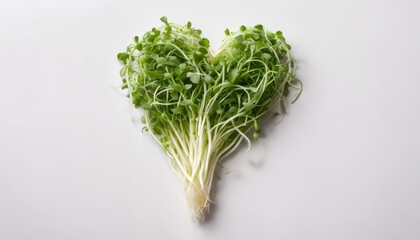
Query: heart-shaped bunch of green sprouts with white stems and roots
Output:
[[118, 17, 300, 220]]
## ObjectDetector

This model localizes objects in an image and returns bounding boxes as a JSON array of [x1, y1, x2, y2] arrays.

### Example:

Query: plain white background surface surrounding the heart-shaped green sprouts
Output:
[[0, 0, 420, 240]]
